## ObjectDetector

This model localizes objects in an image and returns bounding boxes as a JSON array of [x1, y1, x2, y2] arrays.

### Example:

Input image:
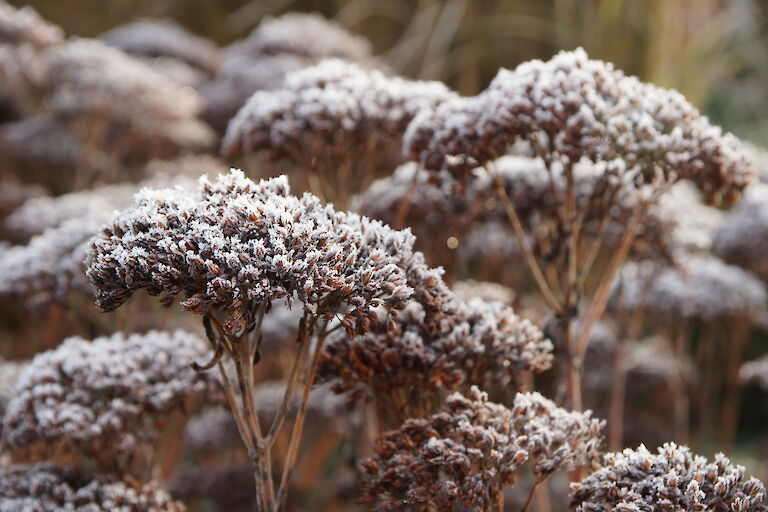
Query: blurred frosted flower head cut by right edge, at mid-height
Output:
[[713, 190, 768, 283]]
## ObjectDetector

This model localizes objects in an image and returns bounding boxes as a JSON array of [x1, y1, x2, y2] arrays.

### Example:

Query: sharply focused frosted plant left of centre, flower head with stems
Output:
[[86, 170, 422, 511]]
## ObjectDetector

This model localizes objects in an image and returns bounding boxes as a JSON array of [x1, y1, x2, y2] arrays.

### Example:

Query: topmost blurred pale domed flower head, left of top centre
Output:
[[228, 13, 372, 62]]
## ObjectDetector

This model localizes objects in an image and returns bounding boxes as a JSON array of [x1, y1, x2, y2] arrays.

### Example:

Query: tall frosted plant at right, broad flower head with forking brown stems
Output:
[[404, 49, 752, 408]]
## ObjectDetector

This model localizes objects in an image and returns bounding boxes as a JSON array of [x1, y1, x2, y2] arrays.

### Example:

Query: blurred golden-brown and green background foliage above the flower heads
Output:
[[11, 0, 768, 145]]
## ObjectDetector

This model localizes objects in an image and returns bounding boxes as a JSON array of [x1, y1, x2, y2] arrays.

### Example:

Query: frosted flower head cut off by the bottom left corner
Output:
[[0, 463, 186, 512]]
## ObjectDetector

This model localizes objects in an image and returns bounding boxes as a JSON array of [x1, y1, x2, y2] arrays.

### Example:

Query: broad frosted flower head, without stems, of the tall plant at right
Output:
[[404, 49, 752, 202]]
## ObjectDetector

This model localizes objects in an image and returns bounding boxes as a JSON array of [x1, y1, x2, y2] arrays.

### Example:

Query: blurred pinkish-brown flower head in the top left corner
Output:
[[0, 0, 64, 49]]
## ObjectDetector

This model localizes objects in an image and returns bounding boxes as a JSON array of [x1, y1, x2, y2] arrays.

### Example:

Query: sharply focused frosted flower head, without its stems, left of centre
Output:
[[86, 169, 416, 334]]
